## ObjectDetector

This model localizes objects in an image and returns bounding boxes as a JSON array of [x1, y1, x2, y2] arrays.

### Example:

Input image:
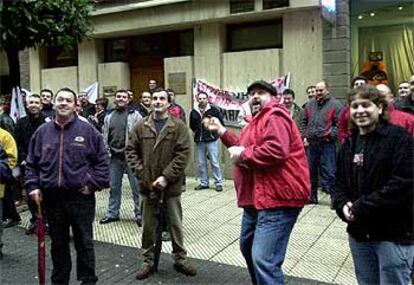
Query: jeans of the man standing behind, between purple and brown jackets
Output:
[[107, 154, 141, 221]]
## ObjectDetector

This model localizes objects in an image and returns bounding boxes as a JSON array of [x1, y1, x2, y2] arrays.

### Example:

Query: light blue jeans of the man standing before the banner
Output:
[[196, 140, 223, 186]]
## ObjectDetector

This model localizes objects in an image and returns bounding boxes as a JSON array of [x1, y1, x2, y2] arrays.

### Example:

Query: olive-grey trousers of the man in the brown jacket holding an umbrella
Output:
[[141, 195, 187, 266]]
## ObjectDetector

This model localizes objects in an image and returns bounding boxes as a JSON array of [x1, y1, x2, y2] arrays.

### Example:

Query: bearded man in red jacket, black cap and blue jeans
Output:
[[204, 81, 310, 284]]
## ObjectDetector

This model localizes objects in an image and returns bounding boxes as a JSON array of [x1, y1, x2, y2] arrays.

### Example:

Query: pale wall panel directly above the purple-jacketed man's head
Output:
[[41, 66, 78, 93]]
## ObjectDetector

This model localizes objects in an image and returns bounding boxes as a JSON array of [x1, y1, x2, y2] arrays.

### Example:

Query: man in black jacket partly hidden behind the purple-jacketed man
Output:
[[15, 94, 46, 234]]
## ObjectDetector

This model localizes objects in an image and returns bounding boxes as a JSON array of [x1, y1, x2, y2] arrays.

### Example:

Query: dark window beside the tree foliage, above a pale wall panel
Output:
[[47, 45, 78, 68]]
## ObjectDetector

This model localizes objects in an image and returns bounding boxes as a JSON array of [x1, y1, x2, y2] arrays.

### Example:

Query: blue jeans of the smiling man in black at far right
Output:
[[349, 236, 414, 285]]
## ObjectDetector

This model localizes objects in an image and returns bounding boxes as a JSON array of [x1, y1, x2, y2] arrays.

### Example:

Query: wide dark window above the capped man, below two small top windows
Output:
[[227, 19, 283, 51]]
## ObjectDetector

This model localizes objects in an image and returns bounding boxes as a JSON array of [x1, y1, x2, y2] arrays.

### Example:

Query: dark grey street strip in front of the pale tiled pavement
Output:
[[0, 227, 334, 285]]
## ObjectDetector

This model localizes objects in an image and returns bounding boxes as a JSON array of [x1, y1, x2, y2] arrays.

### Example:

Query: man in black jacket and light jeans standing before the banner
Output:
[[190, 92, 223, 192]]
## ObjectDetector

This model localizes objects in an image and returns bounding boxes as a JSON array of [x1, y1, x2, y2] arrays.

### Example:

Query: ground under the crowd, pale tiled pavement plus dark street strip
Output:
[[0, 178, 356, 285]]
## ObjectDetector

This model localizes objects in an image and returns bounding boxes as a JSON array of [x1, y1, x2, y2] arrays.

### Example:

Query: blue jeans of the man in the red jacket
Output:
[[240, 208, 301, 285]]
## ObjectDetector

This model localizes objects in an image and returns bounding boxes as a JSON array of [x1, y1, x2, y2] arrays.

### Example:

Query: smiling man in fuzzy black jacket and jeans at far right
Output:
[[334, 86, 414, 284]]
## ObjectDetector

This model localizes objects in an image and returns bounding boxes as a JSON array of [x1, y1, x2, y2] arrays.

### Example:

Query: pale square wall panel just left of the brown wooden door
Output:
[[98, 62, 130, 104]]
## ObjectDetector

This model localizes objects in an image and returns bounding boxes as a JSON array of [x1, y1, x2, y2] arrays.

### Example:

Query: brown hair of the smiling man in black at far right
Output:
[[348, 84, 389, 121]]
